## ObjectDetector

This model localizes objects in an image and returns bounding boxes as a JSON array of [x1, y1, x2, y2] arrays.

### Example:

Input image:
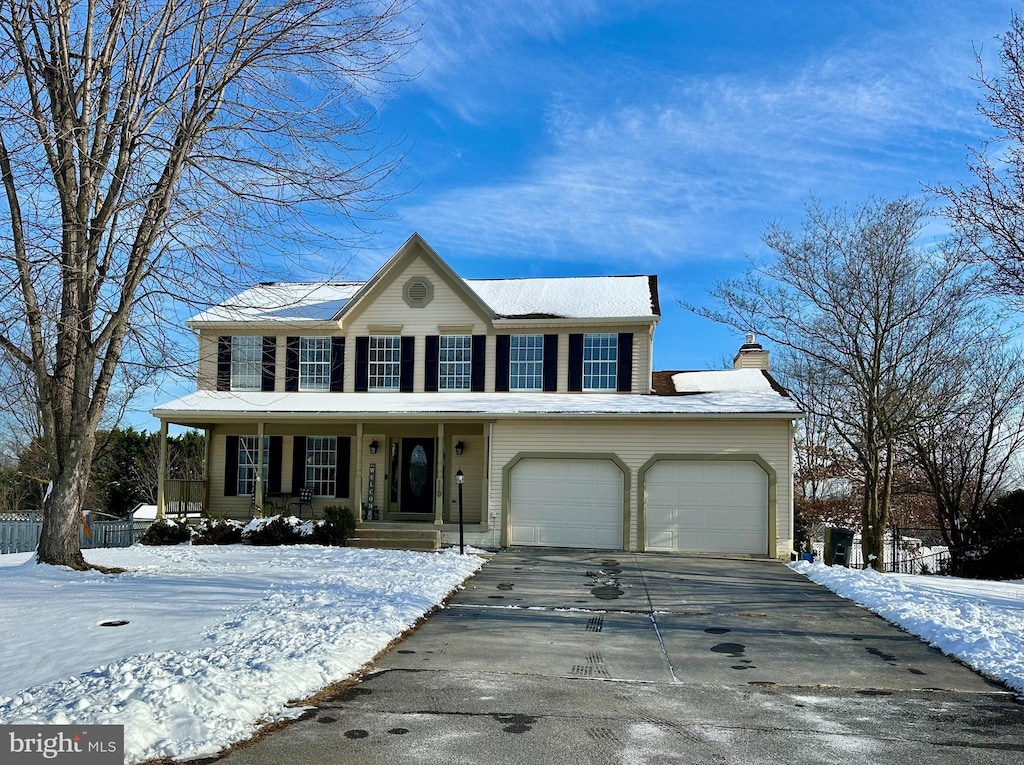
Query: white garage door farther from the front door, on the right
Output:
[[644, 460, 768, 555]]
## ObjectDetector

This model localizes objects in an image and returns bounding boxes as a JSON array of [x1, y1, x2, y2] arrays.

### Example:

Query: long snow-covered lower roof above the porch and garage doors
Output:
[[153, 389, 800, 421]]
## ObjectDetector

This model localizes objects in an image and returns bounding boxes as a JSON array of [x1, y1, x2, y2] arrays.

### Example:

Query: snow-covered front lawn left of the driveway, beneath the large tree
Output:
[[0, 545, 482, 763]]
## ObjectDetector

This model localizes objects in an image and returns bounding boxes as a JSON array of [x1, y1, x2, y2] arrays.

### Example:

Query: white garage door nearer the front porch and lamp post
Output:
[[509, 459, 623, 550]]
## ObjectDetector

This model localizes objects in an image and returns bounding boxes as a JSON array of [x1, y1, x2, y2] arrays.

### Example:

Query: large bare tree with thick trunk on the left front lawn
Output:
[[0, 0, 413, 568]]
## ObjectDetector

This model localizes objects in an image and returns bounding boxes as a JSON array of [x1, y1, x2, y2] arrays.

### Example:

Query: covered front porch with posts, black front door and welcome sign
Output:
[[157, 417, 498, 544]]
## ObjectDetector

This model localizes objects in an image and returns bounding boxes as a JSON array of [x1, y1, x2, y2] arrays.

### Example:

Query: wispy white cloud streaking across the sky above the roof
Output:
[[391, 1, 998, 268]]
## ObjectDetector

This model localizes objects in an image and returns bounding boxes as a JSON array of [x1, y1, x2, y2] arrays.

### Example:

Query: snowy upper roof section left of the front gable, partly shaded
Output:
[[188, 282, 362, 324]]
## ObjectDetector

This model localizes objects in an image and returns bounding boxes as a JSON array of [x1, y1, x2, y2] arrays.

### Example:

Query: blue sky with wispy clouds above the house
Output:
[[134, 0, 1024, 428]]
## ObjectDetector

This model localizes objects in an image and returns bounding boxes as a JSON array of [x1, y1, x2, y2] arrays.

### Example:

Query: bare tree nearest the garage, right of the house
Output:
[[687, 198, 974, 568]]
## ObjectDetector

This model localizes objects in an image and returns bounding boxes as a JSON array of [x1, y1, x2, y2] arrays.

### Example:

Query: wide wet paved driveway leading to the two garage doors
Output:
[[218, 550, 1024, 765]]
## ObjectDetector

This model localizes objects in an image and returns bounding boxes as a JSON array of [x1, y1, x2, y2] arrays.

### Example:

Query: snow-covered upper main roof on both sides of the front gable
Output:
[[188, 277, 658, 324]]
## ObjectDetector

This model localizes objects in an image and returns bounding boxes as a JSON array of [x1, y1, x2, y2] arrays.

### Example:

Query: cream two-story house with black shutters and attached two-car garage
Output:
[[153, 235, 800, 559]]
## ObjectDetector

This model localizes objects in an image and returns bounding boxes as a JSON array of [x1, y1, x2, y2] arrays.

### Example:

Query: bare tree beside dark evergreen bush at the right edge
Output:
[[910, 336, 1024, 571]]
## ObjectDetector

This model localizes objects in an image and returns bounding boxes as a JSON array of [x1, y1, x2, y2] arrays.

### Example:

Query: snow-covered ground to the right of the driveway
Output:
[[790, 561, 1024, 695]]
